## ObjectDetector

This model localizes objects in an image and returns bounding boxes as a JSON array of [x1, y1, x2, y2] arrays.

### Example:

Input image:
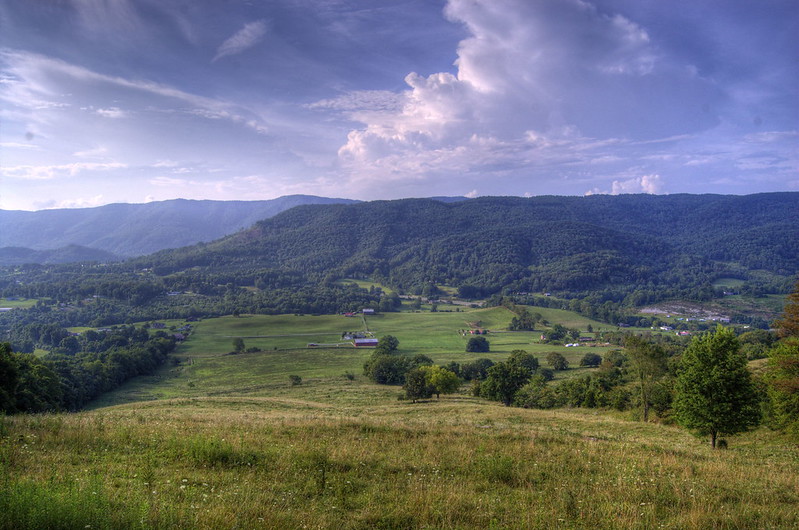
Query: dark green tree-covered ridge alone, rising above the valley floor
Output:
[[137, 193, 799, 295]]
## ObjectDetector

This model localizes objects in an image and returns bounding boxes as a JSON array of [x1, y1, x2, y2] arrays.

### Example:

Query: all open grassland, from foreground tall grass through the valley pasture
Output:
[[0, 308, 799, 529]]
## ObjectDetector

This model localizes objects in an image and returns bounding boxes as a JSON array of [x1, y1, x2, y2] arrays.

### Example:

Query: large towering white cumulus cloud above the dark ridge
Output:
[[319, 0, 716, 192]]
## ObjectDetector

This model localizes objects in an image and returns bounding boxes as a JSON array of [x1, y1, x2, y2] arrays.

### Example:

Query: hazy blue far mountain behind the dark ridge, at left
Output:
[[0, 195, 355, 258]]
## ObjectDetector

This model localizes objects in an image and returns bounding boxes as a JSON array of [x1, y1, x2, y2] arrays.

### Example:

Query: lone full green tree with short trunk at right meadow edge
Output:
[[674, 326, 760, 449]]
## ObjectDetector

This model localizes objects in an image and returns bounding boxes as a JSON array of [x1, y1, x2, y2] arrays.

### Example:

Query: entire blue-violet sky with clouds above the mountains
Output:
[[0, 0, 799, 210]]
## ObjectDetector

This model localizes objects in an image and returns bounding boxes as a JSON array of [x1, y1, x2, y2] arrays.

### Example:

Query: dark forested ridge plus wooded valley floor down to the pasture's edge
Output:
[[0, 193, 799, 329]]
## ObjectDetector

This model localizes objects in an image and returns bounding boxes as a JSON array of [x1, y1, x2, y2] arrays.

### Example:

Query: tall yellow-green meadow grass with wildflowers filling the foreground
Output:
[[0, 396, 799, 528]]
